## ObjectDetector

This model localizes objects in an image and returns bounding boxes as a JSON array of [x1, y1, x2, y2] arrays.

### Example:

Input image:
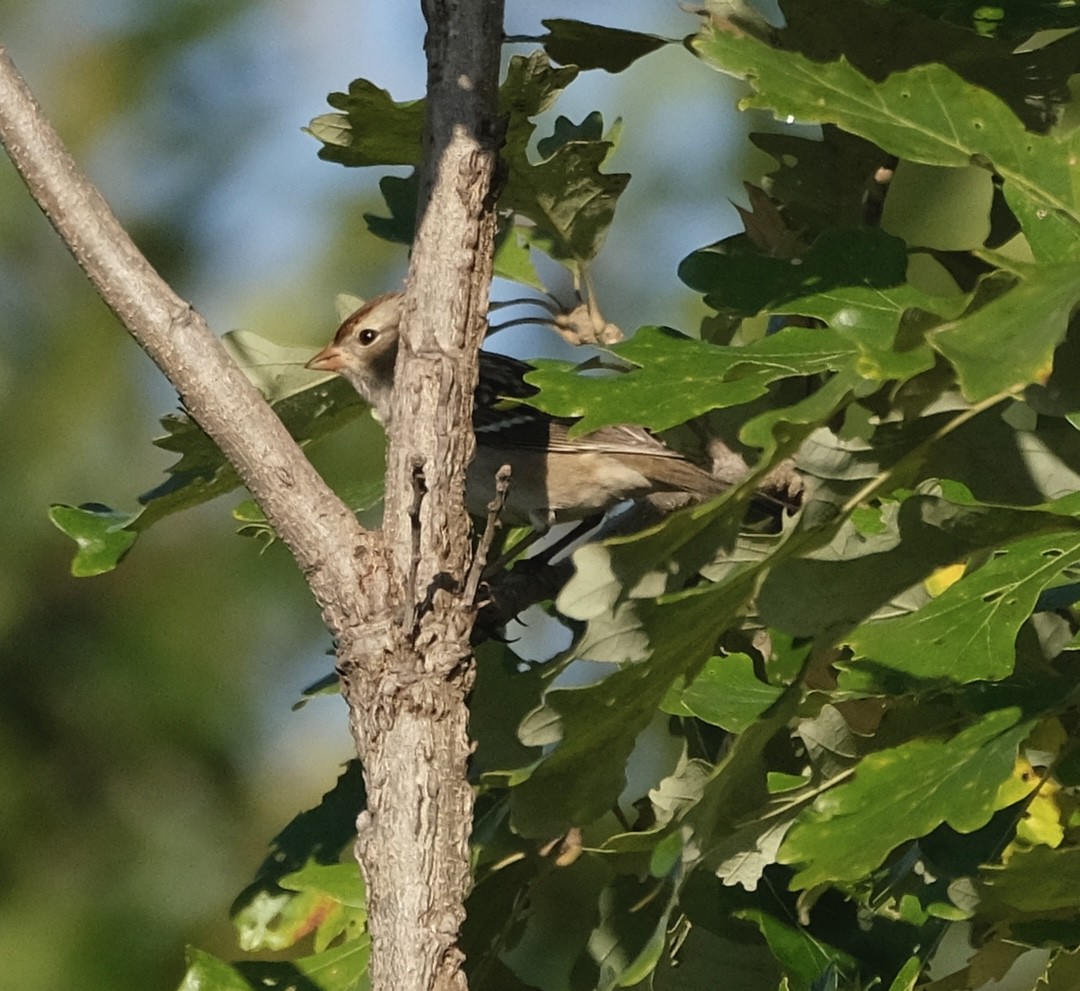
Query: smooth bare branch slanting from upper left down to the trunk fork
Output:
[[0, 47, 381, 626]]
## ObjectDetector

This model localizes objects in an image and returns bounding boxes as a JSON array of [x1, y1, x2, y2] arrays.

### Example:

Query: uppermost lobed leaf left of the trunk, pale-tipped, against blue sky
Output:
[[306, 79, 426, 165]]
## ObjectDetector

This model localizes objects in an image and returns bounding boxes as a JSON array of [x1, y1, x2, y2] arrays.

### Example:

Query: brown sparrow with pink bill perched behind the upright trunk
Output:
[[306, 293, 728, 531]]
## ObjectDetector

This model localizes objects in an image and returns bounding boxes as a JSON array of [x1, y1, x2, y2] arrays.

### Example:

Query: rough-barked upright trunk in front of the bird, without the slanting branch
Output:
[[339, 0, 502, 991]]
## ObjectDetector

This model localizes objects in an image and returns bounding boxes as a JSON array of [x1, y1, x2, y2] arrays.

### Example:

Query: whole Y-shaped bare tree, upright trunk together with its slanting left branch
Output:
[[0, 0, 502, 991]]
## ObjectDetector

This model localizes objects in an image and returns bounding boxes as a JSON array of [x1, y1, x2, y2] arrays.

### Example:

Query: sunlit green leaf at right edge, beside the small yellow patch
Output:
[[841, 532, 1080, 684]]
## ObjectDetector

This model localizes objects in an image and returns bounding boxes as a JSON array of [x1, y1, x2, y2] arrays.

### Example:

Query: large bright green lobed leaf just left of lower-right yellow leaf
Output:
[[780, 708, 1031, 890]]
